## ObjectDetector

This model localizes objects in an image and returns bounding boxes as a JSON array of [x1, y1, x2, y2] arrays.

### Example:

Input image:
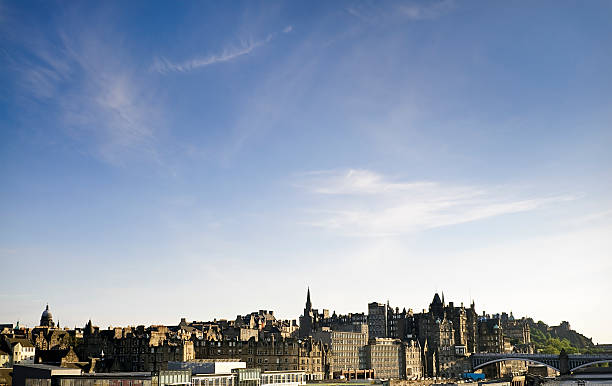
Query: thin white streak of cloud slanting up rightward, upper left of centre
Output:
[[151, 25, 293, 74]]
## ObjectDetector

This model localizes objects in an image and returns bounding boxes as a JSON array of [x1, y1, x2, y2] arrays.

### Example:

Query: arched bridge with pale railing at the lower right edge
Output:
[[471, 352, 612, 374]]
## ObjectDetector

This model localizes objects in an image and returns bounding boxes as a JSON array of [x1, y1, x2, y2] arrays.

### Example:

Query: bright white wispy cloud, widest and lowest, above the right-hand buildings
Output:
[[297, 170, 573, 236]]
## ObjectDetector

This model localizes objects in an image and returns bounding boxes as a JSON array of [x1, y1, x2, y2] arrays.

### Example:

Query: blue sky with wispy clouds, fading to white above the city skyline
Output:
[[0, 0, 612, 343]]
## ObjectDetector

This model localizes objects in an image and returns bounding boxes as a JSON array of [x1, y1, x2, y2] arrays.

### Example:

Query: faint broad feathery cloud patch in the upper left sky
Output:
[[11, 23, 161, 165]]
